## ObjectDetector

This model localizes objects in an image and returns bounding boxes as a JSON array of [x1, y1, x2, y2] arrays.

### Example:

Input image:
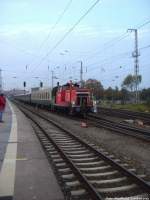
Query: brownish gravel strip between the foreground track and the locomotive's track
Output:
[[31, 111, 150, 180]]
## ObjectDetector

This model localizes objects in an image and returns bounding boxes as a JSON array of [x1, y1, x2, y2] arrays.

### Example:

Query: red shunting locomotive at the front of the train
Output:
[[55, 82, 93, 112]]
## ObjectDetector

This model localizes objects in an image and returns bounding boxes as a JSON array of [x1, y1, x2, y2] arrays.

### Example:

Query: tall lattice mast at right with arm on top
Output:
[[128, 29, 140, 103]]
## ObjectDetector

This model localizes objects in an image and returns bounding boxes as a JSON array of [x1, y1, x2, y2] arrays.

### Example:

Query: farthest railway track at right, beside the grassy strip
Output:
[[98, 107, 150, 124]]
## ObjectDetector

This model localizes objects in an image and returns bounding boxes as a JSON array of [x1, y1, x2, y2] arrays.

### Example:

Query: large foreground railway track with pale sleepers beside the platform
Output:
[[14, 102, 150, 200]]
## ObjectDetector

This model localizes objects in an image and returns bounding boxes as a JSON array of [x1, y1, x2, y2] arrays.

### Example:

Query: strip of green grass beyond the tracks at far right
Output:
[[112, 104, 150, 112]]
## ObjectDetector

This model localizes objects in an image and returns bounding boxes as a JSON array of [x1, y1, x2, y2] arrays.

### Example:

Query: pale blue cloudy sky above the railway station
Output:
[[0, 0, 150, 88]]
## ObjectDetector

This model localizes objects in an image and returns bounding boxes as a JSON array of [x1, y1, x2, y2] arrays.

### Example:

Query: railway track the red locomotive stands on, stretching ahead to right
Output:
[[87, 114, 150, 142]]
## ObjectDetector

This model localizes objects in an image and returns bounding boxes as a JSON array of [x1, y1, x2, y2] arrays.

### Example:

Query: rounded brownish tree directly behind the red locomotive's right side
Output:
[[84, 79, 104, 100]]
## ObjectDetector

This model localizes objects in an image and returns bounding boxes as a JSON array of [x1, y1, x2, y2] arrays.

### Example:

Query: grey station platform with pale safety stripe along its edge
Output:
[[0, 101, 64, 200]]
